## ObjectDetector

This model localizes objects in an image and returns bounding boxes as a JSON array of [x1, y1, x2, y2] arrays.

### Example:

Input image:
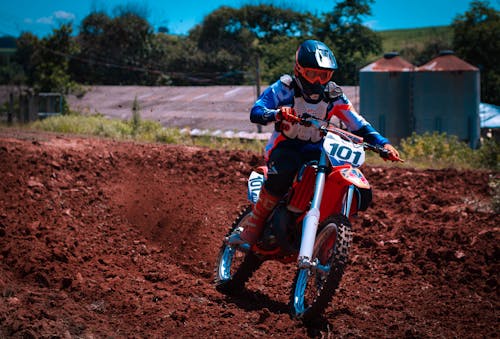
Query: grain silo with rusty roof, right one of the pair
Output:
[[413, 51, 480, 148]]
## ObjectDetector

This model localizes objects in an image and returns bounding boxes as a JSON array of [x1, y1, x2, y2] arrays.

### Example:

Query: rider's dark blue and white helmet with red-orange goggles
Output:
[[294, 40, 337, 102]]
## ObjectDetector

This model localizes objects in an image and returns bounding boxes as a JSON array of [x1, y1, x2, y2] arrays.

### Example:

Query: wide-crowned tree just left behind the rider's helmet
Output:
[[189, 5, 314, 83]]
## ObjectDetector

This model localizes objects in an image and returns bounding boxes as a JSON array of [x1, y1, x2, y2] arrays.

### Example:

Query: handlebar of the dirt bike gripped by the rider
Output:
[[297, 113, 404, 162]]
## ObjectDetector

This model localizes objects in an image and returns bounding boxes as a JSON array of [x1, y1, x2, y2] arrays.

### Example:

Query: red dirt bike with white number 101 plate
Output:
[[215, 116, 400, 321]]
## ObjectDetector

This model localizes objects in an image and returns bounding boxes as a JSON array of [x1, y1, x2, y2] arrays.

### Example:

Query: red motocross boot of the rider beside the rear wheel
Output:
[[227, 187, 280, 249]]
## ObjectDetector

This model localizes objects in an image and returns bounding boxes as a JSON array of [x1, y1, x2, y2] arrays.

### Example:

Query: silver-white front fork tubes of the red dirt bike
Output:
[[298, 152, 354, 269]]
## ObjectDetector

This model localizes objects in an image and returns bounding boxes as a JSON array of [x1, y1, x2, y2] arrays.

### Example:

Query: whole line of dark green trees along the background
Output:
[[0, 0, 500, 105]]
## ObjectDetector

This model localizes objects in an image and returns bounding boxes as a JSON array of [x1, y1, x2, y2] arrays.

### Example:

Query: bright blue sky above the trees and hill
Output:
[[0, 0, 500, 36]]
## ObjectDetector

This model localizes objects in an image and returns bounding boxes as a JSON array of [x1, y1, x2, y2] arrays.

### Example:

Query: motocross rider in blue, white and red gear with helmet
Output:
[[228, 40, 399, 248]]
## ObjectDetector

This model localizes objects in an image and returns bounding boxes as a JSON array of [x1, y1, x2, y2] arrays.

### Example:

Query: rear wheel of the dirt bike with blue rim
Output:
[[215, 206, 262, 294]]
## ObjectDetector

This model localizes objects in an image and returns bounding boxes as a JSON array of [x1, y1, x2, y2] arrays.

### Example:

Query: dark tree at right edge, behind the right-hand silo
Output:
[[452, 0, 500, 105]]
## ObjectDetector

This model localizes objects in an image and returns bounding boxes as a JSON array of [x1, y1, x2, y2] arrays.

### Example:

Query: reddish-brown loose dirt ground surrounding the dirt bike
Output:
[[0, 130, 500, 338]]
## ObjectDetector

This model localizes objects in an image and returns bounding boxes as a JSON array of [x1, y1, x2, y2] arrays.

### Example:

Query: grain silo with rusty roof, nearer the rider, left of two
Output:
[[359, 52, 415, 143]]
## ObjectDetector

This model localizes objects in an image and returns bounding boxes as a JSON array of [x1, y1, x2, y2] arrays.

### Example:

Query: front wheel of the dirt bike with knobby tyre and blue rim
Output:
[[290, 215, 352, 322]]
